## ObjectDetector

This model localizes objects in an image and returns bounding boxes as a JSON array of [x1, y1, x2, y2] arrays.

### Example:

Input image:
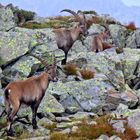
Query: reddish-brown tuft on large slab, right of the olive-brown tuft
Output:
[[80, 70, 94, 80]]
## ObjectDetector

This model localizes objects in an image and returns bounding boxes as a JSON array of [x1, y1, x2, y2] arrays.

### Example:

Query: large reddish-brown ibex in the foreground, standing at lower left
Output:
[[4, 55, 57, 135]]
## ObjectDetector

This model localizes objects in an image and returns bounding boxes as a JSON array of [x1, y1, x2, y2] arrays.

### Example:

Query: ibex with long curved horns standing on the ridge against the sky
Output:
[[53, 9, 88, 65]]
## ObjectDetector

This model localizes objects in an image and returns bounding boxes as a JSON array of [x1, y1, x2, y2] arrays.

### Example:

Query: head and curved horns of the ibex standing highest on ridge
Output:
[[61, 9, 88, 36]]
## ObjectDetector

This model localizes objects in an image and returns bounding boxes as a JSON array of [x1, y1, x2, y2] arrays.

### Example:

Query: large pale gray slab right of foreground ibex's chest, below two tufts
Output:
[[49, 78, 111, 111]]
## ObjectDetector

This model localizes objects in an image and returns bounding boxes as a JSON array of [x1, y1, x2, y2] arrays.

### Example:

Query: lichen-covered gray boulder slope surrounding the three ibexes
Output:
[[0, 3, 140, 140]]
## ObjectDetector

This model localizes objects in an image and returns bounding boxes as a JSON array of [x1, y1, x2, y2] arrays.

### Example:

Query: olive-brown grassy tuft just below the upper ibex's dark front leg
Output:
[[63, 64, 77, 75]]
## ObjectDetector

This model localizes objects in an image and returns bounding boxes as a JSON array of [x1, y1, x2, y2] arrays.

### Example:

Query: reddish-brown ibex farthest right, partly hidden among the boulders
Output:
[[91, 31, 112, 52]]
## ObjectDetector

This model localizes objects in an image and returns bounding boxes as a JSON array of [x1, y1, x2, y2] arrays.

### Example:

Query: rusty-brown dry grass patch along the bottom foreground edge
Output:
[[51, 115, 137, 140]]
